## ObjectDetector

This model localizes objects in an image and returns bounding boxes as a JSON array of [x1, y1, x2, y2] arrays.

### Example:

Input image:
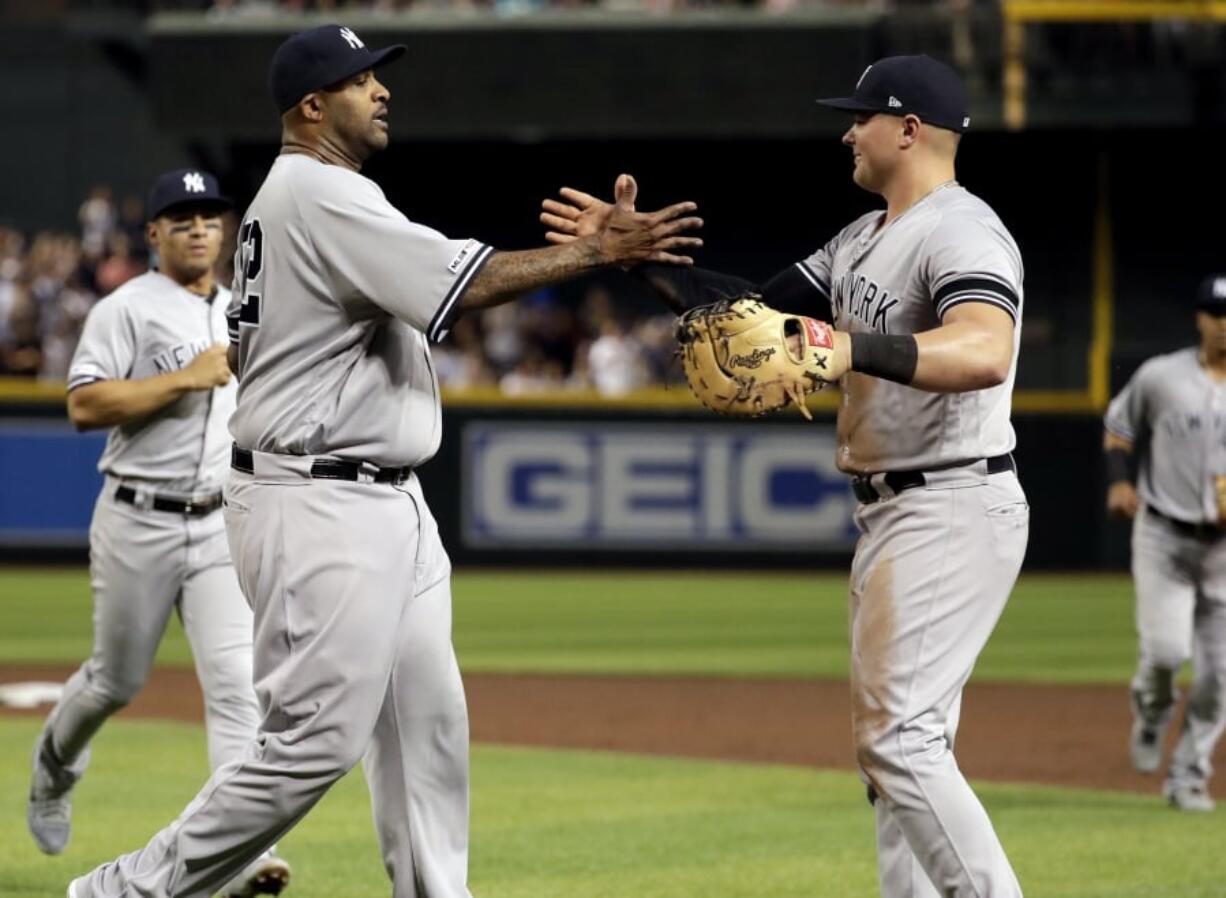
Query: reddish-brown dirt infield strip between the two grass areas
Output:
[[0, 666, 1211, 792]]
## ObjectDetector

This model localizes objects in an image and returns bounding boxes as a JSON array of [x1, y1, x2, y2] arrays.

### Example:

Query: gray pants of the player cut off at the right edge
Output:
[[1132, 507, 1226, 789]]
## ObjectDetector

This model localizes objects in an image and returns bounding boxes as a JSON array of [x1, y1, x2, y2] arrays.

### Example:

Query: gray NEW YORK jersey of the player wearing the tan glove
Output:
[[797, 184, 1022, 472]]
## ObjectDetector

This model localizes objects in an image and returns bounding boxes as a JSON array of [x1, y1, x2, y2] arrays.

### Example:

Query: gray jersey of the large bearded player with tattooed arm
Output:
[[229, 156, 492, 466]]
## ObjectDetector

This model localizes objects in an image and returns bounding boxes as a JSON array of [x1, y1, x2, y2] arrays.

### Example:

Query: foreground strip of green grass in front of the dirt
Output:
[[0, 720, 1226, 898]]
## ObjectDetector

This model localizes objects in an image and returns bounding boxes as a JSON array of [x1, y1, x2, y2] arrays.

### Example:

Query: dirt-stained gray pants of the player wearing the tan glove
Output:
[[850, 462, 1030, 898]]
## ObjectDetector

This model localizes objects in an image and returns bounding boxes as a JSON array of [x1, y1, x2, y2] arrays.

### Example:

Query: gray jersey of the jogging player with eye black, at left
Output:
[[67, 271, 235, 494]]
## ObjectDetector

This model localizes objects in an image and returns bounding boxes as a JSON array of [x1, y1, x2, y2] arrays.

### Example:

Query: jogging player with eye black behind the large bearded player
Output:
[[27, 169, 289, 898]]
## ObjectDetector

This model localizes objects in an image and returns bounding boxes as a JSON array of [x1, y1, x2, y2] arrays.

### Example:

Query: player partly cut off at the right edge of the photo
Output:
[[1103, 269, 1226, 811]]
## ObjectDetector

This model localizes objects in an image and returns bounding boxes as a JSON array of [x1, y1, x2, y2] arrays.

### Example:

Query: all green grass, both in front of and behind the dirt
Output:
[[0, 570, 1226, 898]]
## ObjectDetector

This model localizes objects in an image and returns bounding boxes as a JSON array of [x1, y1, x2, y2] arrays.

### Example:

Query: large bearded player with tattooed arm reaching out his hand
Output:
[[69, 25, 701, 898]]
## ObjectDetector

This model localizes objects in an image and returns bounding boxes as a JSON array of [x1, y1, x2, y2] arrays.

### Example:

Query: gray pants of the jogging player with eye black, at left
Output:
[[44, 477, 260, 773]]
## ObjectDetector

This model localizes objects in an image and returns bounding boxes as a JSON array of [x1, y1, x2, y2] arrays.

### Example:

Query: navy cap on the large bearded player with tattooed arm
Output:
[[268, 25, 407, 113]]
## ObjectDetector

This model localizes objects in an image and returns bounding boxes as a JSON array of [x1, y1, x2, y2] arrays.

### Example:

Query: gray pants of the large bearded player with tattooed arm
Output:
[[72, 453, 470, 898]]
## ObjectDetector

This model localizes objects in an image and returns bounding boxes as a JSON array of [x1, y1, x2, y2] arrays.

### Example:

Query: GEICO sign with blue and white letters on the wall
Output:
[[461, 422, 856, 551]]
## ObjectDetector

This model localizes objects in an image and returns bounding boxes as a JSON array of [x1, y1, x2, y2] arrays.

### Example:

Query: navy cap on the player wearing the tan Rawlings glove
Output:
[[818, 55, 971, 134]]
